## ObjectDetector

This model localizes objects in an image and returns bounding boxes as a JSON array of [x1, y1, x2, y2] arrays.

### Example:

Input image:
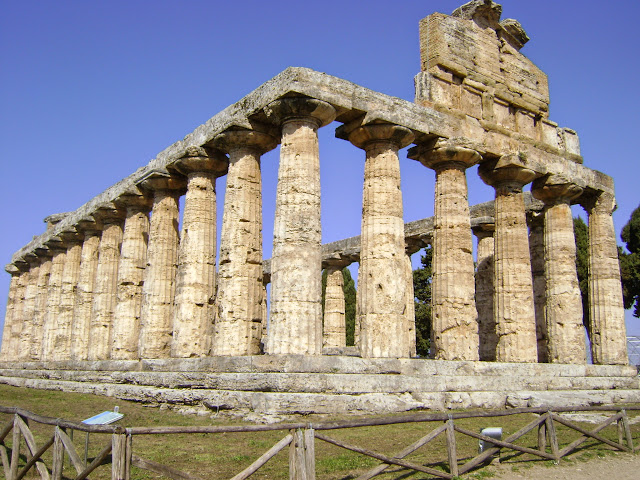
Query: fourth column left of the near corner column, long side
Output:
[[111, 192, 151, 360]]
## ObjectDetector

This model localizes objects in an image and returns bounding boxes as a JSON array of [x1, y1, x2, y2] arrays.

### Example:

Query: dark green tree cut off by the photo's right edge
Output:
[[618, 205, 640, 318]]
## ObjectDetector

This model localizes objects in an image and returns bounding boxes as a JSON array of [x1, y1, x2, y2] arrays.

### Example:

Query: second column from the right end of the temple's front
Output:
[[531, 175, 587, 364]]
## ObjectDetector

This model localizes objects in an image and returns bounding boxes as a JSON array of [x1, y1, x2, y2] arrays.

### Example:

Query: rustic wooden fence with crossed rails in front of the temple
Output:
[[0, 405, 640, 480]]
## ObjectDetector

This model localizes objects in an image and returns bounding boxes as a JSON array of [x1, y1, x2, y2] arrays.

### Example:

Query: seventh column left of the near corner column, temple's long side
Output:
[[53, 233, 82, 360]]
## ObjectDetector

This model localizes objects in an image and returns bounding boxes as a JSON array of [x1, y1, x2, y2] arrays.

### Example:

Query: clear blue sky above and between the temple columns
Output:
[[0, 0, 640, 342]]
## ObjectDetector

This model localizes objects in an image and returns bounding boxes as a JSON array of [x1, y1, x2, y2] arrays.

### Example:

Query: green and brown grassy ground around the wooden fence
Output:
[[0, 385, 640, 480]]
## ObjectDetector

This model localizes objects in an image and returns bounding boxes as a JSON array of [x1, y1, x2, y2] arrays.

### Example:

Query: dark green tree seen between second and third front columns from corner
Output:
[[413, 247, 433, 357]]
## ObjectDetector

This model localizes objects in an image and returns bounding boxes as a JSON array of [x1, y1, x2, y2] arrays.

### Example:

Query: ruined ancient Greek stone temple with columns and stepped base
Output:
[[0, 0, 640, 412]]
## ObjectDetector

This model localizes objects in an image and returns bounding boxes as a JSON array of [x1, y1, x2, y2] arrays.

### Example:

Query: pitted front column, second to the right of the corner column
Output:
[[410, 142, 481, 360]]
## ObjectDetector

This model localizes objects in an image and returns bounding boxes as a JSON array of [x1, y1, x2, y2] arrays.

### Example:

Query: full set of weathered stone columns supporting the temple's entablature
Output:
[[2, 97, 626, 364]]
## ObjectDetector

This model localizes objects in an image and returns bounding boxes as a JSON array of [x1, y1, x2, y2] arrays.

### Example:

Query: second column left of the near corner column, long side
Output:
[[171, 147, 229, 357]]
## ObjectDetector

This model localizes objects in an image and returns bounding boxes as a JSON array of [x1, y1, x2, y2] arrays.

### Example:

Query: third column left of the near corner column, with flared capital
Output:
[[138, 172, 186, 358]]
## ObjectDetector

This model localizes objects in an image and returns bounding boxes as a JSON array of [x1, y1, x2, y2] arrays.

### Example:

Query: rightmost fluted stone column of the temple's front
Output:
[[582, 192, 629, 365]]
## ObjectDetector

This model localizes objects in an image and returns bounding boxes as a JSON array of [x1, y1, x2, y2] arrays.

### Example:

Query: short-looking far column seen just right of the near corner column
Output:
[[322, 262, 347, 348]]
